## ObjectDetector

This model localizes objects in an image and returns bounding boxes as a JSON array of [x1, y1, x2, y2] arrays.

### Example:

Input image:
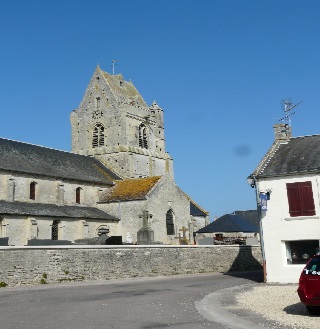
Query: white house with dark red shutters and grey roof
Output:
[[248, 124, 320, 283]]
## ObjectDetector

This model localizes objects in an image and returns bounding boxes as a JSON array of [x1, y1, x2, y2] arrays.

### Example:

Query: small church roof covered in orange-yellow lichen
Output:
[[100, 176, 161, 202]]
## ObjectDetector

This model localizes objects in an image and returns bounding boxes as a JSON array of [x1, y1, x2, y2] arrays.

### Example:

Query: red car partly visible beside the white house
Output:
[[298, 253, 320, 315]]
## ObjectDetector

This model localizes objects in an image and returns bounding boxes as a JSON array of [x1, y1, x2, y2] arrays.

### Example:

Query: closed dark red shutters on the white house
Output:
[[287, 181, 316, 217]]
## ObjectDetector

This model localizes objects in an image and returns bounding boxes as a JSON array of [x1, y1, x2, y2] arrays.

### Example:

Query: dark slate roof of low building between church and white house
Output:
[[196, 214, 259, 233]]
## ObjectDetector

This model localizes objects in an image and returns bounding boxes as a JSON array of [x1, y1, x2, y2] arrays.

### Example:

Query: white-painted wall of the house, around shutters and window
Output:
[[257, 175, 320, 283]]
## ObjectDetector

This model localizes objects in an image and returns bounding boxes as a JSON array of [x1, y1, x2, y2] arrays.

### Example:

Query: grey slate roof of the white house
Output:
[[250, 135, 320, 177]]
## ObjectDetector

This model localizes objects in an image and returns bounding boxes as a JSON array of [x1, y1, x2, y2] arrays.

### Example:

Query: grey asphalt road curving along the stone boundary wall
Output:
[[0, 272, 261, 329]]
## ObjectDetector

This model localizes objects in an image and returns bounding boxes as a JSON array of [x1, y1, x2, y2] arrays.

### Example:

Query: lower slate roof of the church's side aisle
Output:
[[0, 200, 119, 221]]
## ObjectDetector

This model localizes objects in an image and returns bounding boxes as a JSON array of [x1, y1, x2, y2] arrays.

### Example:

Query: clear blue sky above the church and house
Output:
[[0, 0, 320, 219]]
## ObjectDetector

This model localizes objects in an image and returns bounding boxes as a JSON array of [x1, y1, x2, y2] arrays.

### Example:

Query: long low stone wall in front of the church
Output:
[[0, 245, 262, 286]]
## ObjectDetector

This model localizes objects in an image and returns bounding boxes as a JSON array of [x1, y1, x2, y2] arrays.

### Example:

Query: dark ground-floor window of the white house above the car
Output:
[[285, 240, 319, 264]]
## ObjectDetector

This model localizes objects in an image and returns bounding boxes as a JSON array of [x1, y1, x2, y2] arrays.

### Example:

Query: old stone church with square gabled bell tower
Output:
[[0, 66, 209, 245]]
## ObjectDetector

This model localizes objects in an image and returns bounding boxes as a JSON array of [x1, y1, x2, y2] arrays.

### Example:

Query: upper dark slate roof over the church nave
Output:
[[0, 138, 119, 185]]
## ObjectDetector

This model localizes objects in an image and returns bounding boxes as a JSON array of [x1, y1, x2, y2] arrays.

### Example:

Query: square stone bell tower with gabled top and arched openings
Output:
[[70, 66, 173, 178]]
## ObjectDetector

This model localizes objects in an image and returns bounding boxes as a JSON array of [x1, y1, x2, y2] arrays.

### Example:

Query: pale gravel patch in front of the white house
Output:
[[236, 284, 320, 329]]
